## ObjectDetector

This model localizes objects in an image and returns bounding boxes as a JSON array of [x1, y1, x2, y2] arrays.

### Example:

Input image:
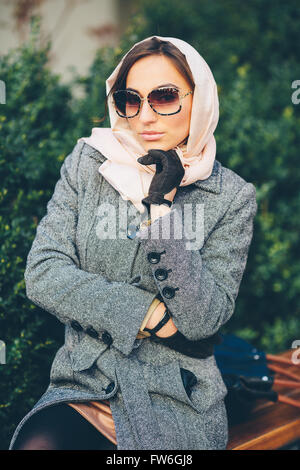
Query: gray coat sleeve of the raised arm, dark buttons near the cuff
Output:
[[137, 183, 257, 341]]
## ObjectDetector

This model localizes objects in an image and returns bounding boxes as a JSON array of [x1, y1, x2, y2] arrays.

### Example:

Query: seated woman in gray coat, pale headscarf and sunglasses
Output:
[[10, 36, 257, 450]]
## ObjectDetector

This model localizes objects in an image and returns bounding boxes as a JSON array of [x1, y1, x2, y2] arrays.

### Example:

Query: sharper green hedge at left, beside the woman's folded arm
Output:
[[0, 17, 76, 448]]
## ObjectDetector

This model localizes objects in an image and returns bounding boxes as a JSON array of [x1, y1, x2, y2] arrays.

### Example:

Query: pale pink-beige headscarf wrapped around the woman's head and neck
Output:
[[78, 36, 219, 213]]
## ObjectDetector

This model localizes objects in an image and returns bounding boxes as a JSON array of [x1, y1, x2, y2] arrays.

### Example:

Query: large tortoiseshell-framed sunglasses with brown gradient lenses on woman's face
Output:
[[112, 87, 193, 118]]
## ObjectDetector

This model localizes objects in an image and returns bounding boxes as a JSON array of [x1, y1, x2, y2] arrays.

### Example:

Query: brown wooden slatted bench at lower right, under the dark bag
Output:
[[227, 349, 300, 450]]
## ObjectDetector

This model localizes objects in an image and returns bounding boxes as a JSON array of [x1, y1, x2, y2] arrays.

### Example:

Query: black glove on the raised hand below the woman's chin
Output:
[[137, 149, 185, 210]]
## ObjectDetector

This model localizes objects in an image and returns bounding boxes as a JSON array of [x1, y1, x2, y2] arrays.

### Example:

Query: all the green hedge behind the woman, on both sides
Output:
[[0, 0, 300, 449]]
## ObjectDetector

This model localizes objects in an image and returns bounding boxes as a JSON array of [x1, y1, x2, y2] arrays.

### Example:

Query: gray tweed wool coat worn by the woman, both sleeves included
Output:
[[9, 141, 257, 450]]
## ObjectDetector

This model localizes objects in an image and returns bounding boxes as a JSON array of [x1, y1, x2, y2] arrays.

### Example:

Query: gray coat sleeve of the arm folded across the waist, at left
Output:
[[24, 142, 155, 355]]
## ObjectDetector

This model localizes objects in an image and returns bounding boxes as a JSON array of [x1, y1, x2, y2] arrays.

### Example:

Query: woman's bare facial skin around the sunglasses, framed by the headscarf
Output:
[[126, 55, 193, 152]]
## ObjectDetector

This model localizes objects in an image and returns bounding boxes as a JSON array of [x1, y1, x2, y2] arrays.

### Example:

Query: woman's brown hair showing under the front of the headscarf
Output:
[[97, 36, 195, 122]]
